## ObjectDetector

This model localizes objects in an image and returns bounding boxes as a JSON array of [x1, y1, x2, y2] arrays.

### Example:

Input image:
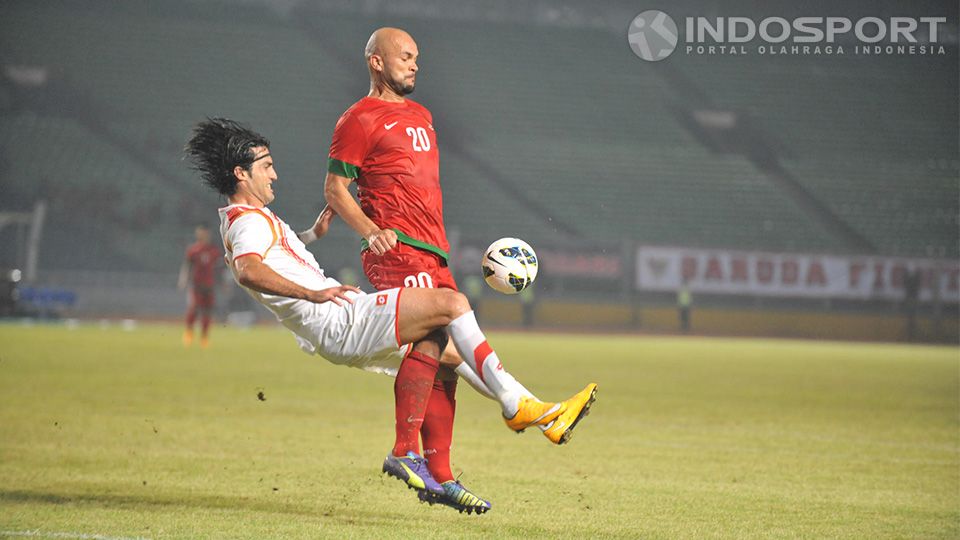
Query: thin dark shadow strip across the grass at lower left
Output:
[[0, 490, 409, 525]]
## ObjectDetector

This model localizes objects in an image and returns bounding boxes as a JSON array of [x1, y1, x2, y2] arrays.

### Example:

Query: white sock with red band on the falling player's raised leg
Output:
[[447, 311, 523, 418]]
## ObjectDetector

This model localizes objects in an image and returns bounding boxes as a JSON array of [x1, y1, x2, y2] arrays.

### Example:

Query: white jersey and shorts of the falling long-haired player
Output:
[[220, 204, 406, 375]]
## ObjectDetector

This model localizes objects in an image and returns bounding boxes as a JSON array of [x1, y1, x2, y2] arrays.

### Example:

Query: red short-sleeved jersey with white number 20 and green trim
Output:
[[327, 97, 450, 255]]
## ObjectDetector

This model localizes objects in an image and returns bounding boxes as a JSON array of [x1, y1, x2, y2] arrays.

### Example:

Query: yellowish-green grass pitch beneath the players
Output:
[[0, 325, 960, 538]]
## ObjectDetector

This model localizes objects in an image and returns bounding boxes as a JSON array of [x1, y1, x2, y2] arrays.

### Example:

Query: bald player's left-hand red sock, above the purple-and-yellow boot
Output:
[[393, 351, 440, 456]]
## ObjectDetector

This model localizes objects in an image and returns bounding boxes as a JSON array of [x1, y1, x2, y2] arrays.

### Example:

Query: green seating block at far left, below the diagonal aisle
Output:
[[0, 112, 188, 269]]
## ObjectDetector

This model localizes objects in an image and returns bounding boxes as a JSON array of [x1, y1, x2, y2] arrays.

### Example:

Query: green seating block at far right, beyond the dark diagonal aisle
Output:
[[683, 53, 960, 257]]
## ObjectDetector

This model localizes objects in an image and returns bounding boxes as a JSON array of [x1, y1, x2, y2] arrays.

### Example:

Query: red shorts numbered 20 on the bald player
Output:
[[360, 242, 458, 291]]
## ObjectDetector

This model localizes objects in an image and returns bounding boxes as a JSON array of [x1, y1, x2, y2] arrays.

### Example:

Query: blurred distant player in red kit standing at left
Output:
[[177, 225, 222, 348]]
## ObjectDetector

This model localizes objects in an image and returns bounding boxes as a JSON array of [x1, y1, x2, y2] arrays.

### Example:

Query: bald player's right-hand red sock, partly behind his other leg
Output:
[[420, 379, 457, 482]]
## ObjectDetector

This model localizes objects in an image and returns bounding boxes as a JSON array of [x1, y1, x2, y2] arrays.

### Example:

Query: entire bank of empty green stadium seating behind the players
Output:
[[0, 1, 958, 278]]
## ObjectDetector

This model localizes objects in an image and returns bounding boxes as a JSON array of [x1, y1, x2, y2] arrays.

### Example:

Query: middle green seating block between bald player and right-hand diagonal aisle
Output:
[[306, 10, 848, 250]]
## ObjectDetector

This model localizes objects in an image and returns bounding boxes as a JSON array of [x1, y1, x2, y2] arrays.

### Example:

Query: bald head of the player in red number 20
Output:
[[363, 27, 420, 99]]
